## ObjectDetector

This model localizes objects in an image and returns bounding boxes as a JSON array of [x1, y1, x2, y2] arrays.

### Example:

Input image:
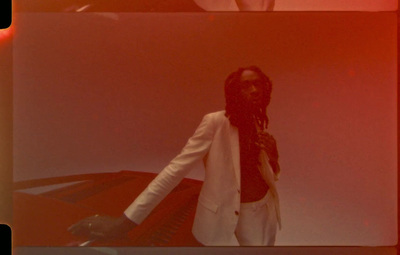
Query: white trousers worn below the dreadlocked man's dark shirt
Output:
[[235, 191, 278, 246]]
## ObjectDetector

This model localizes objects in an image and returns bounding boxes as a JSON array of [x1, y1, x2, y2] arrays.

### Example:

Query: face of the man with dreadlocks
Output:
[[240, 70, 265, 107]]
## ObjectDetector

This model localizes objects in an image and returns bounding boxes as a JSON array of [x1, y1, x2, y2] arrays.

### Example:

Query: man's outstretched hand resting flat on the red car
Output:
[[68, 215, 137, 240]]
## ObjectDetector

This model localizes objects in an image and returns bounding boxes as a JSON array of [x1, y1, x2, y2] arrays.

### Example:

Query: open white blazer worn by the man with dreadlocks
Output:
[[124, 111, 281, 246]]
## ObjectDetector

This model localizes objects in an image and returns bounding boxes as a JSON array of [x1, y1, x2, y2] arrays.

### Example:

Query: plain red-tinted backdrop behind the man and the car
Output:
[[13, 13, 397, 246]]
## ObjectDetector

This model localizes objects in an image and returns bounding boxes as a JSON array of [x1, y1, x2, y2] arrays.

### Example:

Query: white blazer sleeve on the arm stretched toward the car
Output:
[[124, 114, 214, 224]]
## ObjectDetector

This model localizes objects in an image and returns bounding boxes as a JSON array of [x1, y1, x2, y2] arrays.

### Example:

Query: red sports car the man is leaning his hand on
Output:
[[13, 171, 201, 247]]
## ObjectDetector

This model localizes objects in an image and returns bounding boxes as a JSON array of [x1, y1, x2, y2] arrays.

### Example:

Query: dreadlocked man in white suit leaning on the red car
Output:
[[69, 66, 281, 246]]
